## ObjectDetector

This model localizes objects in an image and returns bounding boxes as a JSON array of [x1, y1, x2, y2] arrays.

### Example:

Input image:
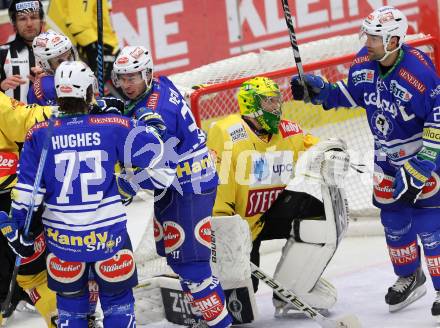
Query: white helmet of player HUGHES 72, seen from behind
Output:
[[55, 61, 98, 101]]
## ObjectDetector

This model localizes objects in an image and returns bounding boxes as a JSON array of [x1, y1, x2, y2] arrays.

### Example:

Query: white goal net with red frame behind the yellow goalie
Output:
[[134, 34, 440, 276]]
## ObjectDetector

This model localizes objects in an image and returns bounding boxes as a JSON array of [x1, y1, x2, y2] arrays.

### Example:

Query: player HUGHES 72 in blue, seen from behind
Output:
[[0, 62, 172, 327]]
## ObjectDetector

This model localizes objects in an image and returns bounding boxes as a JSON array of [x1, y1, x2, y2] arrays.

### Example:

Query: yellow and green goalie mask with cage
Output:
[[238, 77, 282, 134]]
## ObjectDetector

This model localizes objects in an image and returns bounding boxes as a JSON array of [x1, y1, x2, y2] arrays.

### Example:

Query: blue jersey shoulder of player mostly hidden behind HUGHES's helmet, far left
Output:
[[27, 75, 57, 106]]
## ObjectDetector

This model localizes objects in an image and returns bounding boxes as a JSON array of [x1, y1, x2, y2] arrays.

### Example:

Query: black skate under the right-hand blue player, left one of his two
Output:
[[385, 267, 426, 312]]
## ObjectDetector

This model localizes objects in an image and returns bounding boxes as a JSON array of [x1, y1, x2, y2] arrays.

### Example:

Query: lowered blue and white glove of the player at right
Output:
[[393, 156, 436, 204]]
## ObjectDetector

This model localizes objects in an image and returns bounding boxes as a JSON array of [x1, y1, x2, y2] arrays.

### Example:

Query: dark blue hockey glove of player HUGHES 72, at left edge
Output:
[[0, 211, 34, 257]]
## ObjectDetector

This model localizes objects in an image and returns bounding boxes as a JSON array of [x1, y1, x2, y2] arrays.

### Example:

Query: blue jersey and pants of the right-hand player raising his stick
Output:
[[323, 45, 440, 207]]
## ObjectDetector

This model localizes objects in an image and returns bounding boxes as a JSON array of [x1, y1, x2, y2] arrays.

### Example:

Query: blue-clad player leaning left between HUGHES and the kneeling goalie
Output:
[[112, 46, 231, 328]]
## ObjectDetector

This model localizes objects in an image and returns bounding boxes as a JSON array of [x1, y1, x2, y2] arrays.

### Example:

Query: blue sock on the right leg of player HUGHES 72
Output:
[[99, 288, 136, 328]]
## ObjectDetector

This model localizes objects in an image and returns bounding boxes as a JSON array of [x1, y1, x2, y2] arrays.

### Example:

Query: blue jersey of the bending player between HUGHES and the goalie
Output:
[[125, 76, 218, 193]]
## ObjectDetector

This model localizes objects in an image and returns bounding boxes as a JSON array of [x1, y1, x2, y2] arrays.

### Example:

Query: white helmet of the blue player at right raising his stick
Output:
[[360, 6, 408, 61]]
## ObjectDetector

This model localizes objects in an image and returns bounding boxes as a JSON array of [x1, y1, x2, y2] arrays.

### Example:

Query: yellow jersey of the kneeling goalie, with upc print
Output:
[[207, 115, 318, 240]]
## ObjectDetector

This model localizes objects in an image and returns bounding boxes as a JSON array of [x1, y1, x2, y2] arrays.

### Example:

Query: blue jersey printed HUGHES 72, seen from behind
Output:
[[12, 115, 167, 262]]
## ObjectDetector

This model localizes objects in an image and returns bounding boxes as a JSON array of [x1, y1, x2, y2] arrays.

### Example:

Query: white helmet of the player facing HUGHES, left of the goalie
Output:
[[112, 46, 153, 90]]
